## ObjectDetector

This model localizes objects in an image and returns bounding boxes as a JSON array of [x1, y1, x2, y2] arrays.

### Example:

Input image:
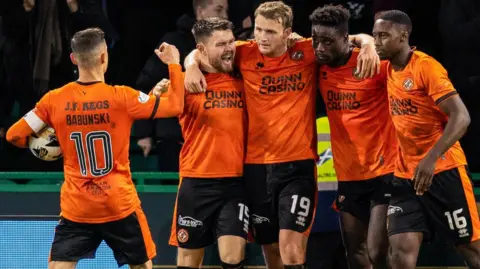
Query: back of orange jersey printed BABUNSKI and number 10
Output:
[[34, 82, 158, 223]]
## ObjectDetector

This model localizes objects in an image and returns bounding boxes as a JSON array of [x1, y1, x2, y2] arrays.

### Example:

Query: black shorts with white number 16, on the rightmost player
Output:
[[387, 166, 480, 245]]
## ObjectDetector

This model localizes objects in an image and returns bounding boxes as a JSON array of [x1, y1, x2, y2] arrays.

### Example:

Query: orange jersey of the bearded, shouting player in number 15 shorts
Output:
[[179, 71, 246, 178]]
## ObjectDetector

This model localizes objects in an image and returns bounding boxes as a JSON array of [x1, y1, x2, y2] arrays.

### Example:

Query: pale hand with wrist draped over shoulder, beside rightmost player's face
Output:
[[349, 34, 380, 78]]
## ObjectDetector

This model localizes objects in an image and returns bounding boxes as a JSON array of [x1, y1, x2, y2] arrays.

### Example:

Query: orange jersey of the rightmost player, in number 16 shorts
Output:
[[387, 51, 467, 179]]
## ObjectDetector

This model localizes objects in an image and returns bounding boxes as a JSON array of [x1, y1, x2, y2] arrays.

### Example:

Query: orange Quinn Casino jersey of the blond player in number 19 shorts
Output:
[[235, 39, 316, 164]]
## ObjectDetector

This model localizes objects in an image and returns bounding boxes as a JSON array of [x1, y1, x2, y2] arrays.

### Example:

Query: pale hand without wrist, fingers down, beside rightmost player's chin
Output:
[[355, 43, 380, 79]]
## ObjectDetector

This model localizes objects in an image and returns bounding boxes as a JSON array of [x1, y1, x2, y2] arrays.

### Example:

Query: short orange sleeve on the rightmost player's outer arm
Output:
[[420, 59, 457, 105]]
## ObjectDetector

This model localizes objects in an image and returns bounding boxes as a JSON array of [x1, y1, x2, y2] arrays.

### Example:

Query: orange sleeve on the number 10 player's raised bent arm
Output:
[[121, 64, 185, 120]]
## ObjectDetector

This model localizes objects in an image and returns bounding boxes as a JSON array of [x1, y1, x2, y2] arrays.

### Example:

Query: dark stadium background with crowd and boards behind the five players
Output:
[[0, 0, 480, 269]]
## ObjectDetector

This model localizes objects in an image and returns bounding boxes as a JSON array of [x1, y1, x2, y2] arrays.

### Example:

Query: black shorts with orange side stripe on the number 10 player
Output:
[[50, 208, 156, 267]]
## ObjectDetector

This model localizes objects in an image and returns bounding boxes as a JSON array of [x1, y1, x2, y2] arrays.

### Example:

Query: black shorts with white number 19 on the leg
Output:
[[244, 160, 317, 245]]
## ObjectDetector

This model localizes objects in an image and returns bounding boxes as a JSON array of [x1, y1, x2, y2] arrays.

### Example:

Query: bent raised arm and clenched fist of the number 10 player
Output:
[[124, 43, 185, 119]]
